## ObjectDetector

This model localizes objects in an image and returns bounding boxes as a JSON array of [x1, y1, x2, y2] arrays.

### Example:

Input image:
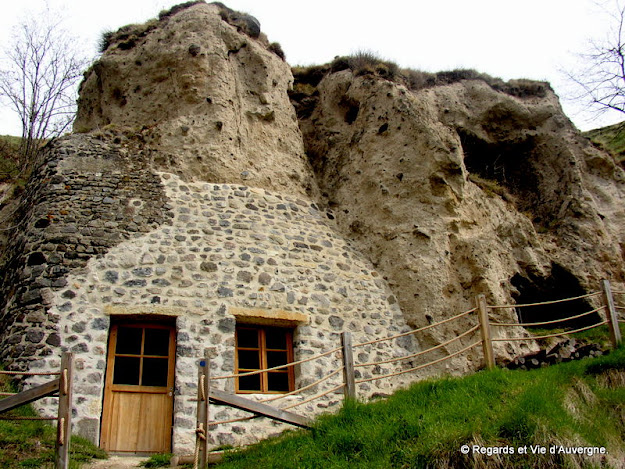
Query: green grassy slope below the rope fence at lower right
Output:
[[219, 348, 625, 469]]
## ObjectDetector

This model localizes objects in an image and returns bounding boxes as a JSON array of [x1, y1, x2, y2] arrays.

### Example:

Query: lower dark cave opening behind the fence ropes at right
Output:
[[511, 263, 601, 329]]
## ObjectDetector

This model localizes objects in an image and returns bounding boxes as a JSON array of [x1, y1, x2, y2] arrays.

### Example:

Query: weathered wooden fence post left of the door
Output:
[[55, 352, 74, 469]]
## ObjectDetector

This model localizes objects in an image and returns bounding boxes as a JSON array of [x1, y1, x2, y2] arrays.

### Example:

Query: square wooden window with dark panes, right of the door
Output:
[[235, 324, 295, 393]]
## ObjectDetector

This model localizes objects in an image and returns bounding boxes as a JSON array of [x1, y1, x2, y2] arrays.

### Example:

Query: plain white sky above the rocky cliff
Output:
[[0, 0, 625, 135]]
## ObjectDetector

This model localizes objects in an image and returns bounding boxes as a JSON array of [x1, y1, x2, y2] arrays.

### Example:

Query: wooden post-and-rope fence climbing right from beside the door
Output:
[[194, 280, 625, 467]]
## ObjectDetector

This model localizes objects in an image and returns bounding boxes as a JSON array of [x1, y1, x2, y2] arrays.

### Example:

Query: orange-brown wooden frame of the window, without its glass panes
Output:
[[234, 323, 295, 394]]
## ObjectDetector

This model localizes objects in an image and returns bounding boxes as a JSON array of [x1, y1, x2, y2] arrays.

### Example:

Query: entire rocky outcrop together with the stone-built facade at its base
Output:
[[0, 2, 625, 448]]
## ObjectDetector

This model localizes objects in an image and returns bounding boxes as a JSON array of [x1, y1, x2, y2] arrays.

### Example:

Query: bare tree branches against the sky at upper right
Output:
[[567, 1, 625, 119]]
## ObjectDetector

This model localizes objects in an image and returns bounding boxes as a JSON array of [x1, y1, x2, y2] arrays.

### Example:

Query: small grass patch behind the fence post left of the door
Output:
[[0, 376, 107, 469]]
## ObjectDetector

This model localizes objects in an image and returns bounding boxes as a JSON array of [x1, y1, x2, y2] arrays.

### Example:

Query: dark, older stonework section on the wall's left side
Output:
[[0, 136, 167, 369]]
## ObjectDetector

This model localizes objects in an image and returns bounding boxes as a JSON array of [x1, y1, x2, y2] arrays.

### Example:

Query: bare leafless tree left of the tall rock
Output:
[[0, 12, 87, 171]]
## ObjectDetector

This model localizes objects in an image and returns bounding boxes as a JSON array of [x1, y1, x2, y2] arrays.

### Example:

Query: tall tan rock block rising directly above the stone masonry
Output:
[[74, 3, 317, 196]]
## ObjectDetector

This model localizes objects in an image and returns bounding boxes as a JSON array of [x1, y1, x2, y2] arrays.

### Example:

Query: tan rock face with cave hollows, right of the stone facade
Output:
[[295, 70, 625, 340]]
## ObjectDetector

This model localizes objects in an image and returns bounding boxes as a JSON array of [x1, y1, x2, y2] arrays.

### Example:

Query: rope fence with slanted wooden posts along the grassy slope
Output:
[[196, 280, 625, 461]]
